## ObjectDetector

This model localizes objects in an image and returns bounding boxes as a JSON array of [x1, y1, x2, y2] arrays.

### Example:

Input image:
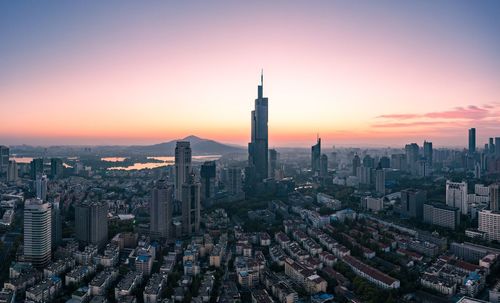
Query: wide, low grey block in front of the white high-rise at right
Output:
[[424, 203, 460, 229]]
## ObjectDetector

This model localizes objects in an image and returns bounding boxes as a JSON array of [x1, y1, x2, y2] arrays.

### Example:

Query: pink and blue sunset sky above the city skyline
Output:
[[0, 0, 500, 147]]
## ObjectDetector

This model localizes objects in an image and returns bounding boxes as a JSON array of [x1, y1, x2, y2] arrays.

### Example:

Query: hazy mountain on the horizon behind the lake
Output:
[[127, 135, 244, 155]]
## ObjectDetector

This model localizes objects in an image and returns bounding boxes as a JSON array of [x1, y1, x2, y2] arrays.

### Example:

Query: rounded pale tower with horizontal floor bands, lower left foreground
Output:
[[24, 199, 52, 267]]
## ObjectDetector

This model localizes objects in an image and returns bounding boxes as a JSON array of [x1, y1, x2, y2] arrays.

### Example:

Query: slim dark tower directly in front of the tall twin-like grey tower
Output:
[[182, 175, 201, 236]]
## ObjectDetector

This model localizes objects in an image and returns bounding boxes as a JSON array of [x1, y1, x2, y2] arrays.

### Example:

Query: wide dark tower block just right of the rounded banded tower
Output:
[[75, 202, 108, 246]]
